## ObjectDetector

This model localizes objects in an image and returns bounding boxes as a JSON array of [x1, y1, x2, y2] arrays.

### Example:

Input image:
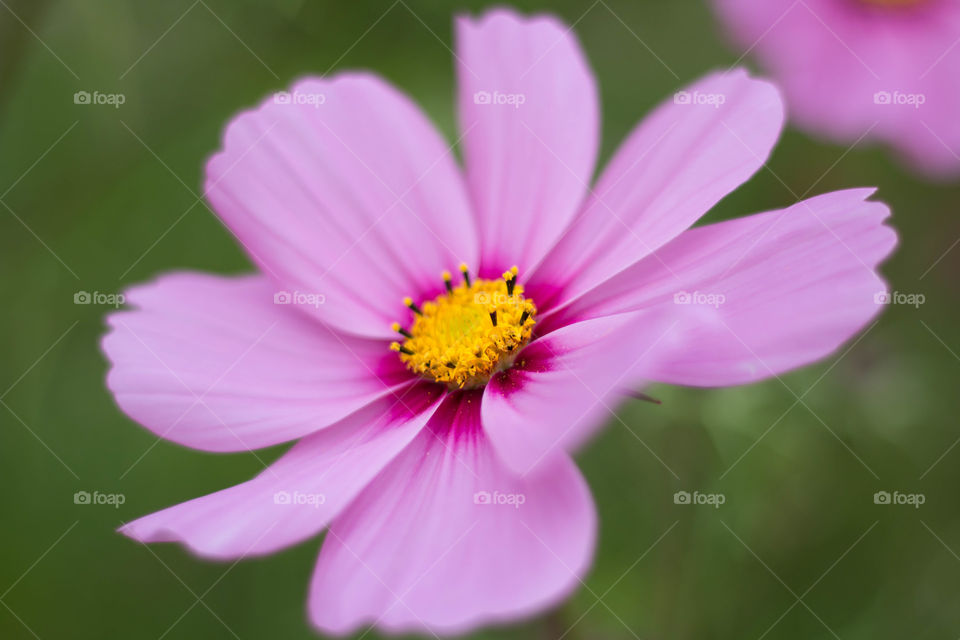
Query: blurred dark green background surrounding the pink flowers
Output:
[[0, 0, 960, 640]]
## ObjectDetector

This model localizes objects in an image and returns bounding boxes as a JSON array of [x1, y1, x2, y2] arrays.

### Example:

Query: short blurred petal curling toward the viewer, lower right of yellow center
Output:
[[482, 313, 677, 474]]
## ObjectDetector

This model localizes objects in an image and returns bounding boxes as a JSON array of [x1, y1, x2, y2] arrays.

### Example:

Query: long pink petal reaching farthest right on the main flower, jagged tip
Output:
[[546, 189, 896, 386]]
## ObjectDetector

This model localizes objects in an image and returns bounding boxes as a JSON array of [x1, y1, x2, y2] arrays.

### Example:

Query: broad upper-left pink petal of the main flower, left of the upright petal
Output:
[[206, 73, 478, 337]]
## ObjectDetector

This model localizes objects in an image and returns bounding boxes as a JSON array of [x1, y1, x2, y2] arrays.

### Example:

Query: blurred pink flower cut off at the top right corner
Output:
[[714, 0, 960, 177]]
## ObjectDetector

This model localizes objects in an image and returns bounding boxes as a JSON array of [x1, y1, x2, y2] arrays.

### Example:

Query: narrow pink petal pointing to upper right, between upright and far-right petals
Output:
[[531, 70, 783, 308]]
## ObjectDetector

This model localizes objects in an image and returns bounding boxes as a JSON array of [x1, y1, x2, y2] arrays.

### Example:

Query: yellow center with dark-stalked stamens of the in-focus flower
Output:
[[390, 265, 537, 389]]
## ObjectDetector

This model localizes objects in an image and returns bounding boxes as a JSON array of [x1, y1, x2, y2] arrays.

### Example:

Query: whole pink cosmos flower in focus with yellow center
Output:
[[103, 10, 896, 634]]
